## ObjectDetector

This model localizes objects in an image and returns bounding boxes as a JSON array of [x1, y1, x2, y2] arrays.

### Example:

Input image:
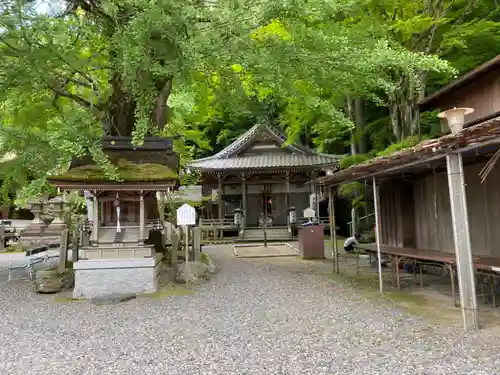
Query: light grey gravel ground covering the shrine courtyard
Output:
[[0, 246, 500, 375]]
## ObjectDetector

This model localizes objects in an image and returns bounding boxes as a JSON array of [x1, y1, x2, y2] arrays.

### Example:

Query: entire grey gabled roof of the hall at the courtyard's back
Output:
[[188, 124, 343, 170]]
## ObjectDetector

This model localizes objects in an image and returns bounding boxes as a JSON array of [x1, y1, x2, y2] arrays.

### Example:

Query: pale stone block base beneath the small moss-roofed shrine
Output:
[[73, 254, 162, 299]]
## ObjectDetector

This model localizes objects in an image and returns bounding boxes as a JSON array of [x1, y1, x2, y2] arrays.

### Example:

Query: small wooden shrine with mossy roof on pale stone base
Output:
[[49, 136, 179, 298]]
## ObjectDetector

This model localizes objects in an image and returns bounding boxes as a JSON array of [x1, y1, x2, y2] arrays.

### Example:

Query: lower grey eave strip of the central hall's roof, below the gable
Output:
[[190, 153, 339, 170]]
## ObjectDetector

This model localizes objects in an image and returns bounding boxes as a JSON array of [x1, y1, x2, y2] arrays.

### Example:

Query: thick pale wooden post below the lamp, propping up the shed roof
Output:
[[446, 154, 479, 330]]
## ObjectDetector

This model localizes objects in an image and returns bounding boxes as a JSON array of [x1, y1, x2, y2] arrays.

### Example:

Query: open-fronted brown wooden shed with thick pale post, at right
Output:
[[316, 57, 500, 328]]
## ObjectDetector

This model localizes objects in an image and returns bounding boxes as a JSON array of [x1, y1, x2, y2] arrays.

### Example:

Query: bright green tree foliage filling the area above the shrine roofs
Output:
[[0, 0, 496, 206]]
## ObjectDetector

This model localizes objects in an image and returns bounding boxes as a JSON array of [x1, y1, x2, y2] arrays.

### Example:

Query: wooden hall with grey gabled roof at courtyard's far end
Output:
[[187, 124, 341, 239]]
